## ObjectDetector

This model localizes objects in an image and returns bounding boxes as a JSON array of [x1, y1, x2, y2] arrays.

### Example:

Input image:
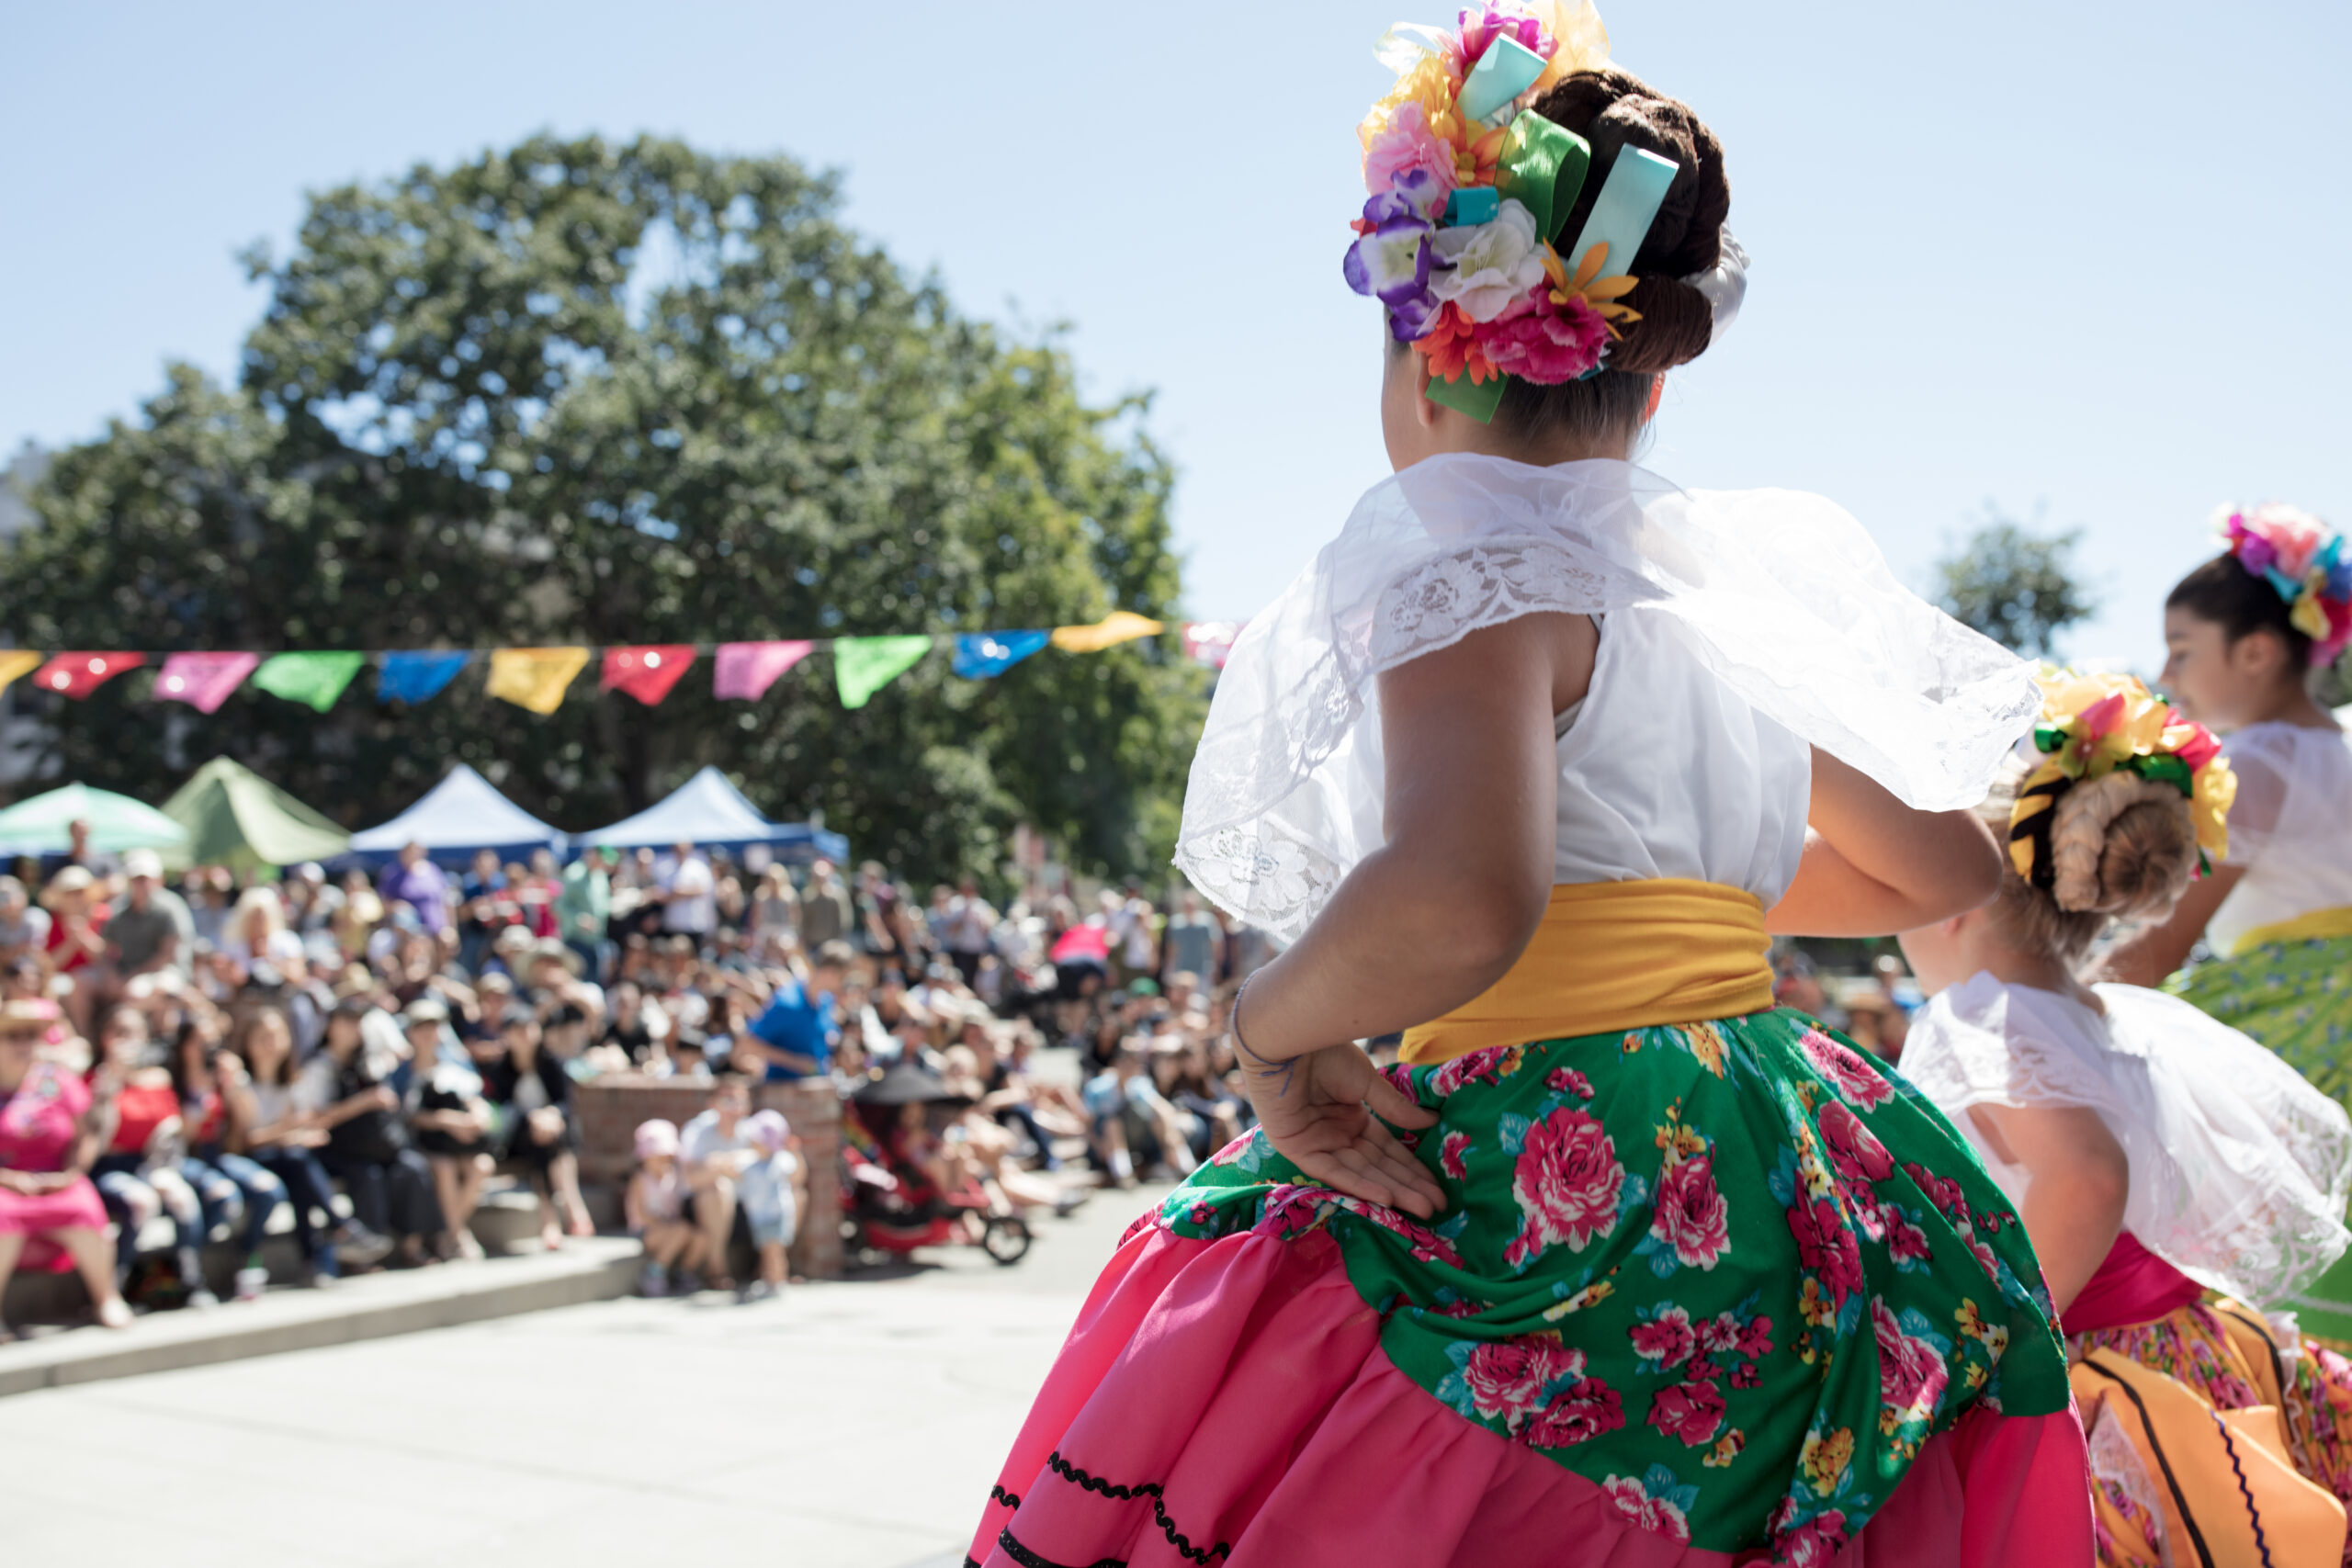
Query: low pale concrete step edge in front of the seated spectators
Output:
[[0, 1236, 639, 1396]]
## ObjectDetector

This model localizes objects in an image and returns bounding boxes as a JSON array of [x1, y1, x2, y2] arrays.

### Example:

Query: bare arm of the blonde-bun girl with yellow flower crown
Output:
[[1969, 1105, 2131, 1312]]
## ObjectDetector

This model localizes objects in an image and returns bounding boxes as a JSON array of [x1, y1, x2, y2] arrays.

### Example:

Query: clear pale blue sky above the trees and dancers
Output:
[[0, 0, 2352, 663]]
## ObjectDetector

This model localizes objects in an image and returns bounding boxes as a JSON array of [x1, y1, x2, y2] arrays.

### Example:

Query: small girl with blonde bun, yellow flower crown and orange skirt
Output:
[[1903, 674, 2352, 1568]]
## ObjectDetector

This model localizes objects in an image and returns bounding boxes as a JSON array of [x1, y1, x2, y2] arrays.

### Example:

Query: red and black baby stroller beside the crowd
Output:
[[842, 1063, 1030, 1265]]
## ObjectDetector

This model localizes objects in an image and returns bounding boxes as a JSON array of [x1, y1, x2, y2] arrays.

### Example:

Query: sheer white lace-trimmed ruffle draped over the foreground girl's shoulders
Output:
[[1176, 454, 2041, 941]]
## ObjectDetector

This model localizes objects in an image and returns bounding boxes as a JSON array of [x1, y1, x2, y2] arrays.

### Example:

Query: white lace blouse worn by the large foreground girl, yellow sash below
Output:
[[1176, 454, 2041, 941]]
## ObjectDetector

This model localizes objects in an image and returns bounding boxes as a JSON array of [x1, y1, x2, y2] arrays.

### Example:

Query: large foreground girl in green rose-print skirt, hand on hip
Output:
[[971, 3, 2091, 1568]]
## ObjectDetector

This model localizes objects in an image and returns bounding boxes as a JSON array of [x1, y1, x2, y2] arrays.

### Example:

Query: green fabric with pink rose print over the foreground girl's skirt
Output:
[[1138, 1010, 2067, 1563]]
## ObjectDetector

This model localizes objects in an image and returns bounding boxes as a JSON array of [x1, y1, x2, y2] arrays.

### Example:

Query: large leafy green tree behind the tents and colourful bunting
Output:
[[0, 139, 1202, 874]]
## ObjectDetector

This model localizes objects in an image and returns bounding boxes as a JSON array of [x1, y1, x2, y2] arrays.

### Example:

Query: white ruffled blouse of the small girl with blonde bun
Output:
[[1903, 974, 2352, 1304]]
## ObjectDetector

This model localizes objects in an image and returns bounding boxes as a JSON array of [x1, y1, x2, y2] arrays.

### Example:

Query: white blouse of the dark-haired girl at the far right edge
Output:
[[2206, 724, 2352, 954]]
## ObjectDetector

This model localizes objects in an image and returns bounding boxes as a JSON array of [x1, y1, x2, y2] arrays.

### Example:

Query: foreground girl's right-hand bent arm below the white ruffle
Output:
[[1764, 748, 2002, 936]]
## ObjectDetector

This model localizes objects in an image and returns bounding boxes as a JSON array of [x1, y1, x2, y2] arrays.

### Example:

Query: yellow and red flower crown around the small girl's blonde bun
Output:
[[2008, 665, 2237, 909]]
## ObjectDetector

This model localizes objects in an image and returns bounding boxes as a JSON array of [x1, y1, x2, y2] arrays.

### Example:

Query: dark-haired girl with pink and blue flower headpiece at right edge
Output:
[[2112, 505, 2352, 1105]]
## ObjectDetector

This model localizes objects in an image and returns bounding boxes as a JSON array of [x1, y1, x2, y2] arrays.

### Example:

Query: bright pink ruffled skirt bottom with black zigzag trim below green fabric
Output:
[[969, 1224, 2091, 1568]]
